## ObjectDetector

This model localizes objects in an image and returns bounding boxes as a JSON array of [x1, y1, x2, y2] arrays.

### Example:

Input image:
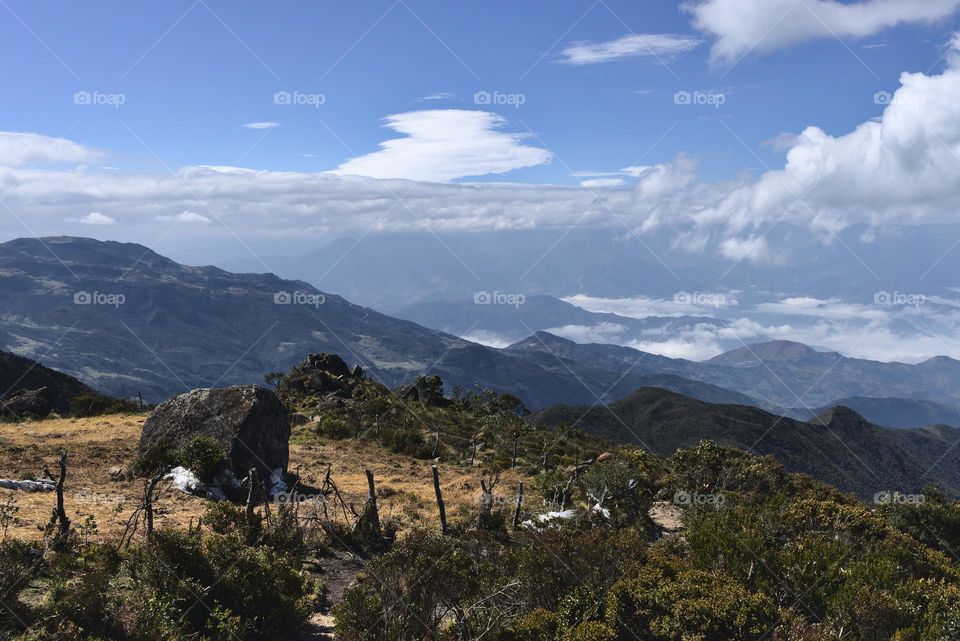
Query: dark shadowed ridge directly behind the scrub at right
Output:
[[532, 389, 960, 497]]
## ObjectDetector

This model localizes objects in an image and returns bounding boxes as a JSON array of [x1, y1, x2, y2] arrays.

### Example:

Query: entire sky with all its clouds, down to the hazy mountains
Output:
[[0, 0, 960, 362]]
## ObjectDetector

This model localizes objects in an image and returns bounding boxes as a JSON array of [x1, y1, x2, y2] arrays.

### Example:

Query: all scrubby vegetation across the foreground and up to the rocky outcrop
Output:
[[0, 360, 960, 641]]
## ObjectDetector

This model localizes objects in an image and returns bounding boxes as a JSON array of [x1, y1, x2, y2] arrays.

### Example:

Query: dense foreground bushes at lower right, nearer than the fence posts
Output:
[[336, 444, 960, 641]]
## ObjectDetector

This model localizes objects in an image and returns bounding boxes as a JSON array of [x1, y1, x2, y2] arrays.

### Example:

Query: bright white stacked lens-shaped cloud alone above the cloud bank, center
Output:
[[331, 109, 553, 182]]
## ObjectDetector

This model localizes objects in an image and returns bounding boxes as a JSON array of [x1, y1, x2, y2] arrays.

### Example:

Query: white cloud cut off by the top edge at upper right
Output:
[[683, 0, 960, 63]]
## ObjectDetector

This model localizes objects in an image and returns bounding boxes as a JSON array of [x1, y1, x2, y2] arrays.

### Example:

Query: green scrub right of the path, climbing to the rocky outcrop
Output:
[[276, 370, 960, 641]]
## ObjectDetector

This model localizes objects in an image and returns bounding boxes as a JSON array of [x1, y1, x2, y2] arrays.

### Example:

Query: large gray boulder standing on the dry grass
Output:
[[139, 385, 290, 480]]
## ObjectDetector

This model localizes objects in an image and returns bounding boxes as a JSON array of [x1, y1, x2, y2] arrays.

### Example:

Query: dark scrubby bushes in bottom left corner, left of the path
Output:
[[0, 503, 323, 641]]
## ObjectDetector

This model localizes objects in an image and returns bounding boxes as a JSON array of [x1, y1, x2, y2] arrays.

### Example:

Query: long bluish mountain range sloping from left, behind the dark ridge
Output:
[[0, 237, 960, 424]]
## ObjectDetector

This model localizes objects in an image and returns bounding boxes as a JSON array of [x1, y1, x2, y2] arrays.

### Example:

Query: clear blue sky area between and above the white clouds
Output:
[[0, 0, 957, 185]]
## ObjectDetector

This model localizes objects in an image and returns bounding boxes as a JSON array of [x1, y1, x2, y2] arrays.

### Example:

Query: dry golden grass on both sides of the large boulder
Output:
[[0, 415, 518, 540]]
